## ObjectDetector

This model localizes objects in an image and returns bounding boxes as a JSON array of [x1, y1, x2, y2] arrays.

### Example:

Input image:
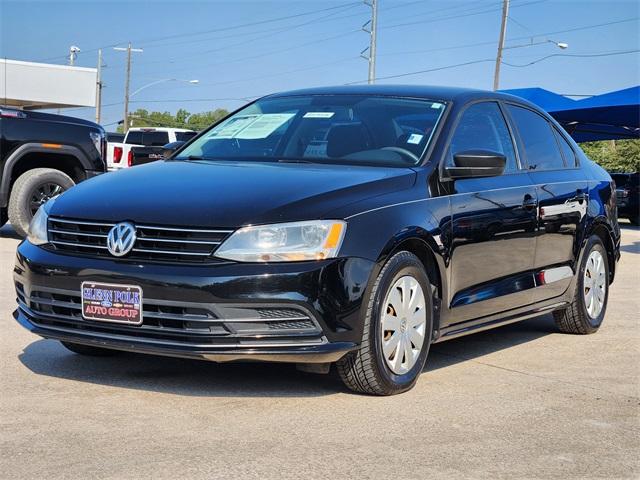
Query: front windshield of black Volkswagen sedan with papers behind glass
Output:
[[176, 95, 445, 166]]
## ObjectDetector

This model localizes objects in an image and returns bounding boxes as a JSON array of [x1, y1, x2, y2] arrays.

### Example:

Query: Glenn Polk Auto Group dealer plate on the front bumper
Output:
[[81, 282, 142, 325]]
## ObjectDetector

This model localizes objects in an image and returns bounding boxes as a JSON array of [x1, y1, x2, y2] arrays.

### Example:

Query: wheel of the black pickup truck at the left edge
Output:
[[9, 168, 75, 237]]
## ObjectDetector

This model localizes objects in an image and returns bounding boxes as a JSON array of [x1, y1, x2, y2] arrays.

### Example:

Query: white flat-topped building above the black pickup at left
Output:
[[0, 59, 97, 109]]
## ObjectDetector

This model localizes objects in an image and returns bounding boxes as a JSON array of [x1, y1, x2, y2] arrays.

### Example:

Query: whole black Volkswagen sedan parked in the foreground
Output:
[[14, 86, 620, 395]]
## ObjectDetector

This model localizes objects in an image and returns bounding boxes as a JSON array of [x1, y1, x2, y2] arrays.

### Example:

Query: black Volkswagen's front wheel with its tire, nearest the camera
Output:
[[336, 251, 433, 395]]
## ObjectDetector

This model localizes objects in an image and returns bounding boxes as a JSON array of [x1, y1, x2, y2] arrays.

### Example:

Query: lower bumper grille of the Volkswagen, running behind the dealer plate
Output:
[[16, 283, 322, 346]]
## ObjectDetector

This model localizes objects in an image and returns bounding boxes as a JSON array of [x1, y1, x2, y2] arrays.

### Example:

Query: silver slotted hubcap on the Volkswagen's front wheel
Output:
[[380, 275, 427, 375]]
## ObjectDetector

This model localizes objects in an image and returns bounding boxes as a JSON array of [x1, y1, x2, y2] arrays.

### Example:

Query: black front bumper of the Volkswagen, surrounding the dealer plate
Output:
[[14, 241, 375, 363]]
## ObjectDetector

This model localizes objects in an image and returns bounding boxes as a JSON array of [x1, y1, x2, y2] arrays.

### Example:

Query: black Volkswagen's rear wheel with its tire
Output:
[[553, 235, 609, 335]]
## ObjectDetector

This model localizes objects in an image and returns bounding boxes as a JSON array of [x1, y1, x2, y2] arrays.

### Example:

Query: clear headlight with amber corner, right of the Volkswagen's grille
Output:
[[215, 220, 347, 262]]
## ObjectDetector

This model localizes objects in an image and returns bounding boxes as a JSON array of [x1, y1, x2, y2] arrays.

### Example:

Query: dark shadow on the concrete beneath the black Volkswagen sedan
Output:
[[13, 315, 555, 397]]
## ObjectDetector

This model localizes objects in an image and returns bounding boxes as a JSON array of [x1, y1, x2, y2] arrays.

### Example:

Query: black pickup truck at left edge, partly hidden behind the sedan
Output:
[[0, 107, 106, 236]]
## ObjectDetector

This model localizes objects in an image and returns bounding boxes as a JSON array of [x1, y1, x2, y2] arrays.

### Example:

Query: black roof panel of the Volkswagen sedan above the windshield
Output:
[[268, 85, 530, 105]]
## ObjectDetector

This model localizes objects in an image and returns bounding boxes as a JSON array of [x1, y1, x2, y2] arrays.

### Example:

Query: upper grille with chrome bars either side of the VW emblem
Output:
[[48, 217, 232, 263]]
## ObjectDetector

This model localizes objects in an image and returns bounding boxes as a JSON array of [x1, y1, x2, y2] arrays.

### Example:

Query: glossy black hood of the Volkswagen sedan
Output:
[[50, 160, 416, 227]]
